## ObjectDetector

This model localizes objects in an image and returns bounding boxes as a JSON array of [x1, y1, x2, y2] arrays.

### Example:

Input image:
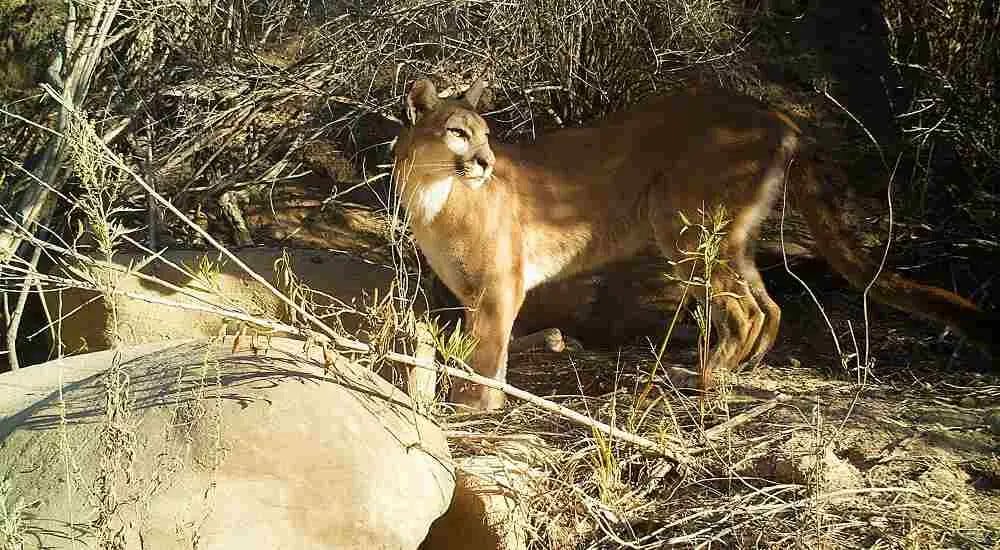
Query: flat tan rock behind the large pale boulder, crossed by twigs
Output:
[[45, 248, 395, 353]]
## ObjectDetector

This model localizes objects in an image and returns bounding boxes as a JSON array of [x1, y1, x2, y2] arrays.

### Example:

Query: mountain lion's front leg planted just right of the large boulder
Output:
[[451, 285, 524, 410]]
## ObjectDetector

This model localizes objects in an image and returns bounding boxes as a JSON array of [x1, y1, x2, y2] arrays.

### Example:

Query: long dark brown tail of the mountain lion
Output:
[[788, 154, 1000, 362]]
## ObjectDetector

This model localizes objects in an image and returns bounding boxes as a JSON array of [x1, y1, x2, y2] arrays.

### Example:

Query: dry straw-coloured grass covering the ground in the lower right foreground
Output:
[[448, 349, 1000, 549]]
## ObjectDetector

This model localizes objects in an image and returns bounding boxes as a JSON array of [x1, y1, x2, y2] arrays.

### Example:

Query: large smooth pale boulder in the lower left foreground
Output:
[[0, 338, 455, 550]]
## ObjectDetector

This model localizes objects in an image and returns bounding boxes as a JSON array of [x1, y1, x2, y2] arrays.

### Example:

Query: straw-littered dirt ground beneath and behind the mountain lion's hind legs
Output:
[[451, 276, 1000, 548]]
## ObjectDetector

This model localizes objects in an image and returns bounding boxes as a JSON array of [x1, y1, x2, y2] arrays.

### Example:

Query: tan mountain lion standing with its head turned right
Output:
[[394, 80, 987, 409]]
